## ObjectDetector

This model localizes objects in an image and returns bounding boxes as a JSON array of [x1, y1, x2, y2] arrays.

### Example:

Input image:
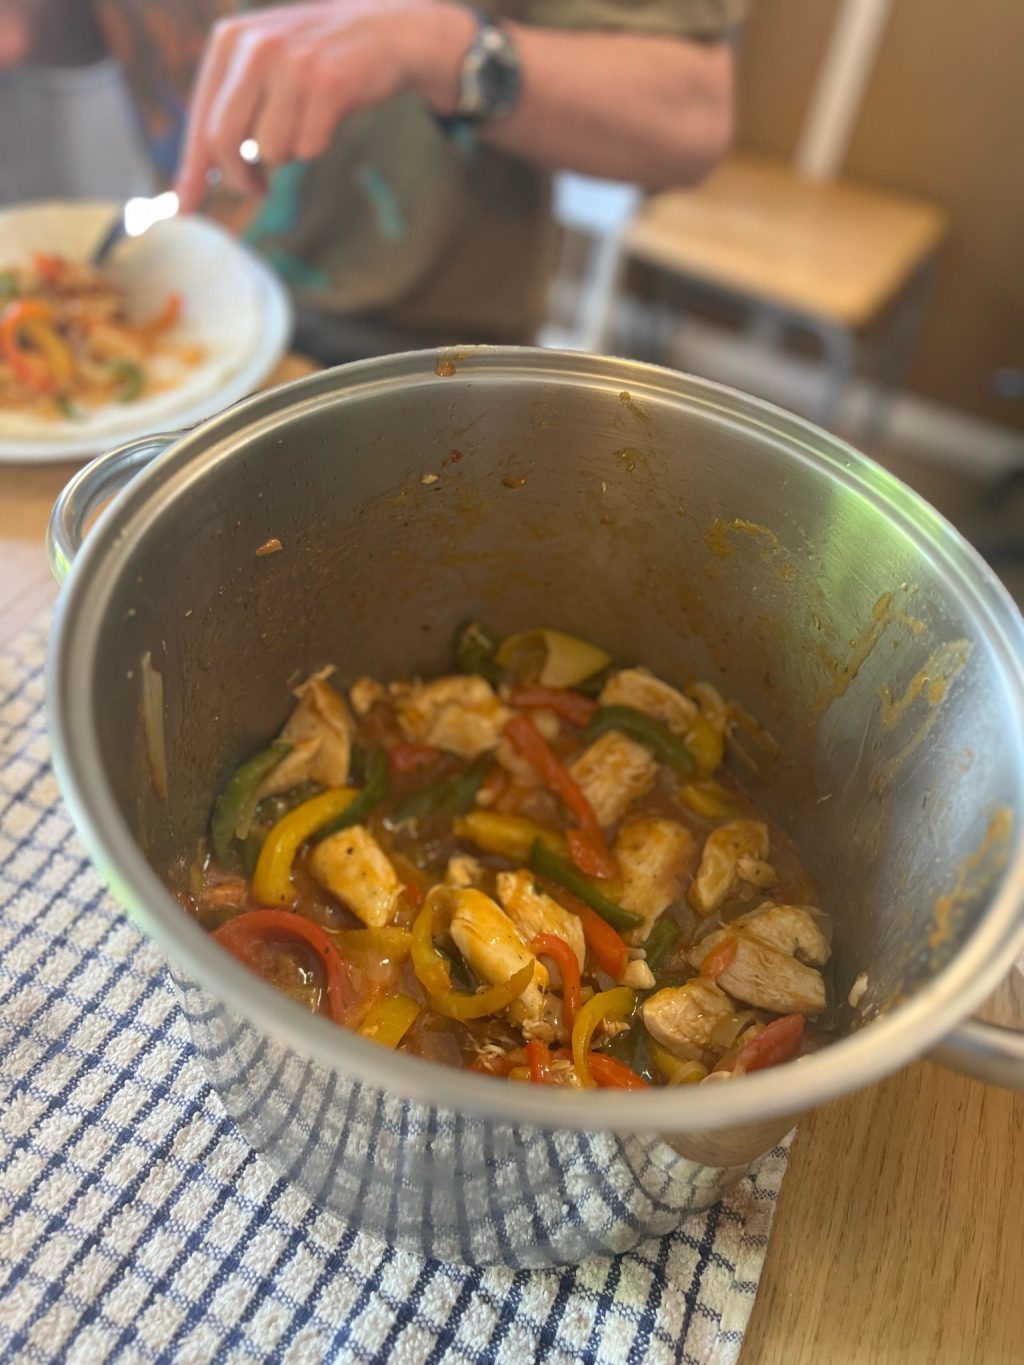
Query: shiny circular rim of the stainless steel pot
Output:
[[46, 347, 1024, 1134]]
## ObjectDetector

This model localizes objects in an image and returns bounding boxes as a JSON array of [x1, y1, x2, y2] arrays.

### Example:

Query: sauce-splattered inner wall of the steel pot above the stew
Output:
[[97, 354, 1021, 1025]]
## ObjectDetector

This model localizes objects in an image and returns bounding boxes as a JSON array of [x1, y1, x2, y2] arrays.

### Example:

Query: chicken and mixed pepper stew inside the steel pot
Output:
[[187, 622, 830, 1089]]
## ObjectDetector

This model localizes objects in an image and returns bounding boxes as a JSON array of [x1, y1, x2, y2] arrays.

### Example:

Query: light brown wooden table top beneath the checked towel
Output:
[[0, 360, 1024, 1365]]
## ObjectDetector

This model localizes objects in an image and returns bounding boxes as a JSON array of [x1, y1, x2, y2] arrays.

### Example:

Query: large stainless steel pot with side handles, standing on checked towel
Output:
[[49, 349, 1024, 1265]]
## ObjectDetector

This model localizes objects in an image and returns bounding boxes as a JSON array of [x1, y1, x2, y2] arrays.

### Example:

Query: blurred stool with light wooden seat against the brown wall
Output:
[[621, 156, 946, 434]]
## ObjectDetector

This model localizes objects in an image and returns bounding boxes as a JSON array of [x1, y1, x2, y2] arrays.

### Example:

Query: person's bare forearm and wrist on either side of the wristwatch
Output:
[[421, 11, 732, 188]]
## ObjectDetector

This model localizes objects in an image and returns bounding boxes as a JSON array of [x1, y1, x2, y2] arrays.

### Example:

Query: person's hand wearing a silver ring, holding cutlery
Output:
[[177, 0, 475, 210]]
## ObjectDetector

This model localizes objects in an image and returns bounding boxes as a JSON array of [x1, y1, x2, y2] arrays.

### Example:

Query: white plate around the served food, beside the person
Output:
[[0, 202, 292, 463]]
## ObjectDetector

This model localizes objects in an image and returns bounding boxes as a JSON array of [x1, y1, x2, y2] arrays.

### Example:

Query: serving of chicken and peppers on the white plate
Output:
[[0, 251, 203, 420]]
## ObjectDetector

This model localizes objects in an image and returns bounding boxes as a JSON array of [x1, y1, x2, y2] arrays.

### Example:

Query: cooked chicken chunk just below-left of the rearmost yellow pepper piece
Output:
[[390, 677, 512, 759]]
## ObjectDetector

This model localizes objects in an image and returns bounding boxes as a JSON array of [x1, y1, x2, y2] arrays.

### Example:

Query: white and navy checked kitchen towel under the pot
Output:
[[0, 622, 786, 1365]]
